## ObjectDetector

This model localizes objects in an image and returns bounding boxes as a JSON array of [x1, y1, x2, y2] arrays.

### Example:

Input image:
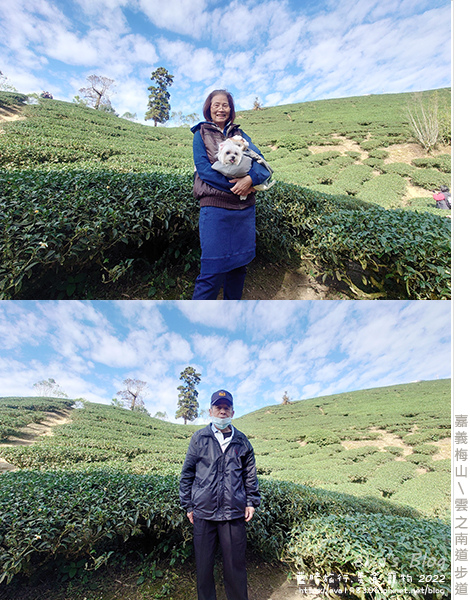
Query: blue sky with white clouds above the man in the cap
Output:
[[0, 301, 451, 421]]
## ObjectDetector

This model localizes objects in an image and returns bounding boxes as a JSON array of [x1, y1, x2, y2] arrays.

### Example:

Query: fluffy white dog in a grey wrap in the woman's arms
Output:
[[212, 135, 274, 200]]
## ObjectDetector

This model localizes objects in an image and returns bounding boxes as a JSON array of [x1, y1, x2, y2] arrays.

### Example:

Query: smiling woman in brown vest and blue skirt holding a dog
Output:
[[191, 90, 270, 300]]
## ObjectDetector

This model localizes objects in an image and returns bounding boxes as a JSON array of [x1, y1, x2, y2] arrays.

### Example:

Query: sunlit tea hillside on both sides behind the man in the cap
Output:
[[0, 380, 450, 515]]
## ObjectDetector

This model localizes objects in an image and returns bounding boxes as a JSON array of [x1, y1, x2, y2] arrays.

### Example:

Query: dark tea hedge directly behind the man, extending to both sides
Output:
[[0, 468, 422, 583]]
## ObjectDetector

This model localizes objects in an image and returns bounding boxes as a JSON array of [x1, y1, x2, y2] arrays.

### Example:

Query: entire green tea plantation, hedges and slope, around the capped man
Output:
[[0, 380, 451, 599]]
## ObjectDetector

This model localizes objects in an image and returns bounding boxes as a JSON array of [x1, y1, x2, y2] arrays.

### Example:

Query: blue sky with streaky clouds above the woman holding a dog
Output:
[[0, 0, 451, 124]]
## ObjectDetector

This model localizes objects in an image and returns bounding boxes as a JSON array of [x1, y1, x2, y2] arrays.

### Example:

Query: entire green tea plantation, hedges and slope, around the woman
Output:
[[0, 89, 451, 299]]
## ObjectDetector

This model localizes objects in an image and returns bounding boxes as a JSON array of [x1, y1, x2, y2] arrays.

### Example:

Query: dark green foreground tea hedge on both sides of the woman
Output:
[[0, 169, 450, 299]]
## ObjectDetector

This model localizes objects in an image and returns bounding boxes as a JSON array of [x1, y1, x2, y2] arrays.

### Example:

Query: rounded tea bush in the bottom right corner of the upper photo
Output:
[[308, 207, 451, 300]]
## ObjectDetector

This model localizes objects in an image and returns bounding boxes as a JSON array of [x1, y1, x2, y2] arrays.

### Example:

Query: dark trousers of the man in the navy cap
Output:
[[194, 517, 248, 600]]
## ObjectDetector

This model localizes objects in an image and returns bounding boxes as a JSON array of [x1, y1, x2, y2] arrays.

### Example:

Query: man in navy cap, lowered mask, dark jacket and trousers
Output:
[[180, 390, 260, 600]]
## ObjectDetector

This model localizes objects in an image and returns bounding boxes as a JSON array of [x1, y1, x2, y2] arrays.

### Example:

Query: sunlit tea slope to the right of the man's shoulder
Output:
[[238, 380, 451, 514]]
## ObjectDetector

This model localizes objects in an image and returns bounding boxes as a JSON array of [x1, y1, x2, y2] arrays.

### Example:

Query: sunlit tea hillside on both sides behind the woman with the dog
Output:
[[0, 88, 451, 204]]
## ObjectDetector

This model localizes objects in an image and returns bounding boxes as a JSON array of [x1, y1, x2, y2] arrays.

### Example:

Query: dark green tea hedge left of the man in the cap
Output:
[[0, 469, 191, 582]]
